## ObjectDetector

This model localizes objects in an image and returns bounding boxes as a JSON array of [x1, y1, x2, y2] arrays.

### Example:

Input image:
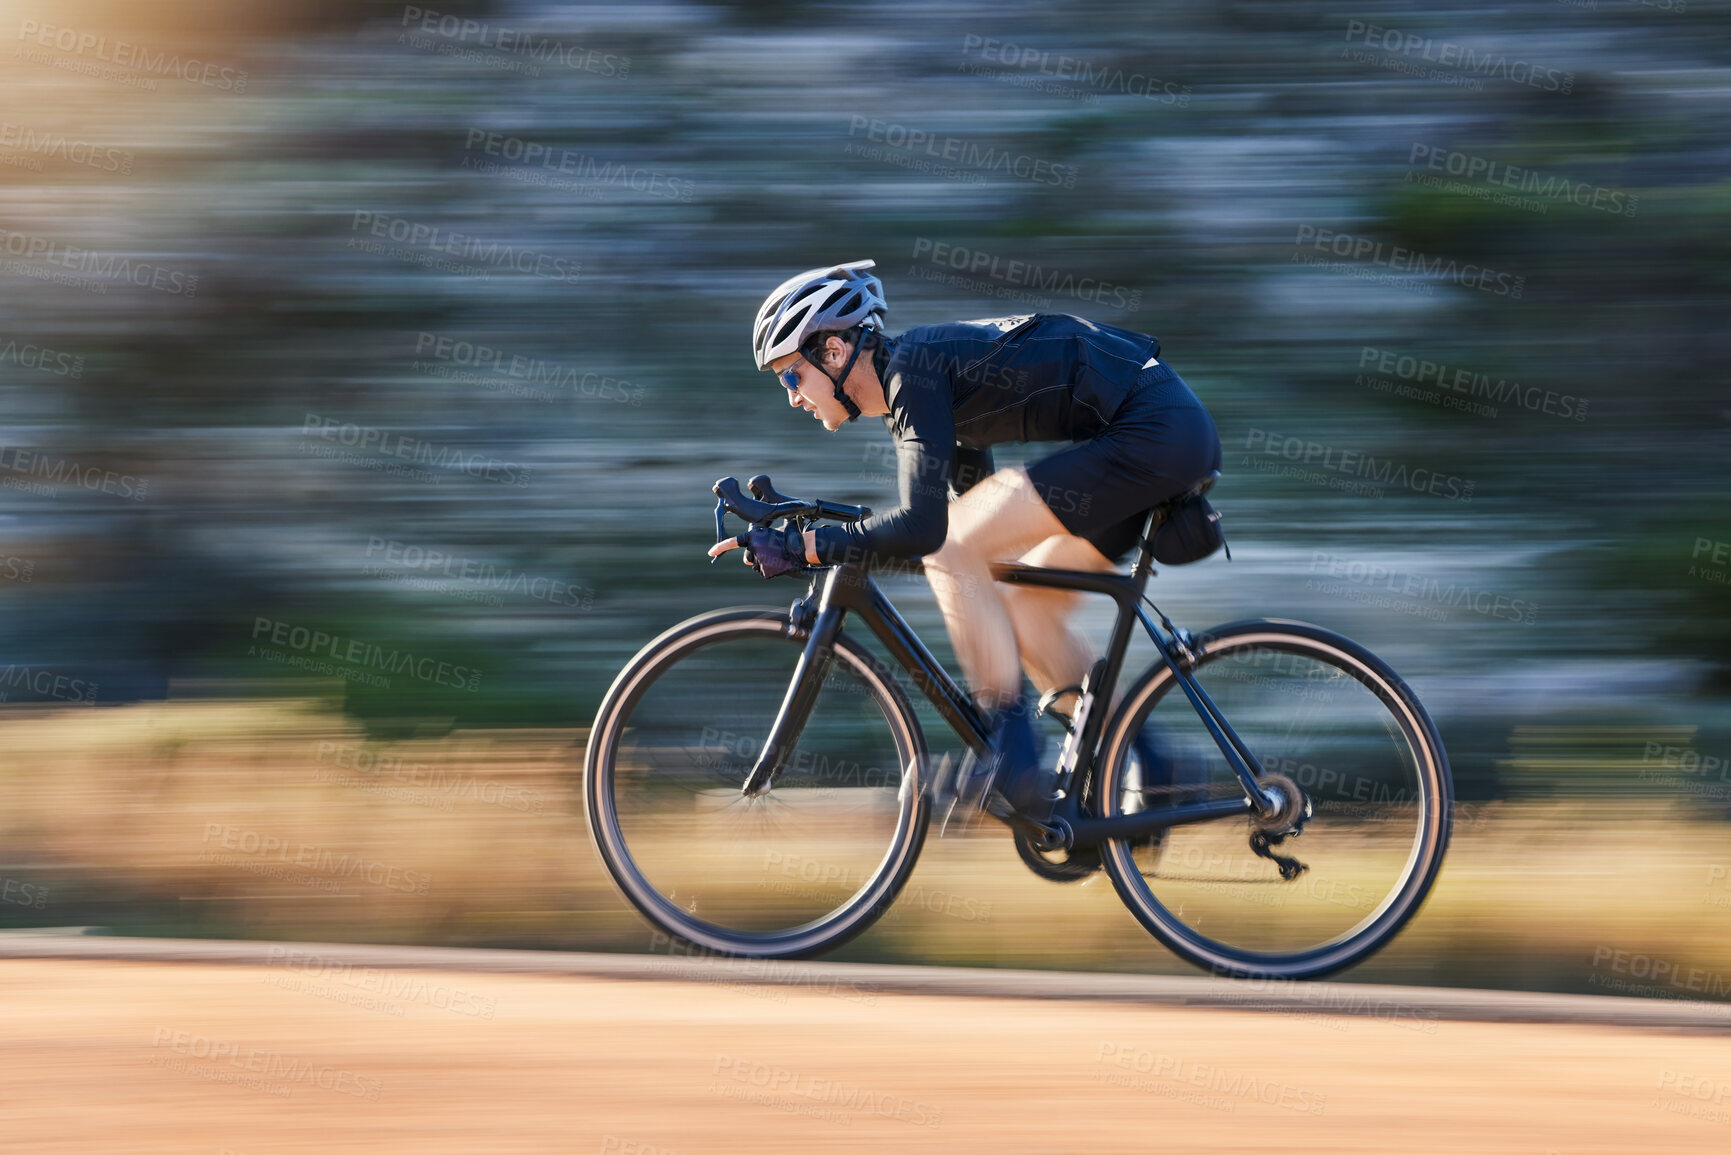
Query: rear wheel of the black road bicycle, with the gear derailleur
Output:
[[1096, 622, 1451, 978]]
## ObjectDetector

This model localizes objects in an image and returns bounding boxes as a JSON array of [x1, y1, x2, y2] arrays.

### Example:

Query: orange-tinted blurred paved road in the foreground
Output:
[[10, 935, 1731, 1155]]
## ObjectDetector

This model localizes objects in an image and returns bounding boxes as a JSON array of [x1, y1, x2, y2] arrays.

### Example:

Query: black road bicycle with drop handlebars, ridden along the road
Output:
[[585, 476, 1451, 978]]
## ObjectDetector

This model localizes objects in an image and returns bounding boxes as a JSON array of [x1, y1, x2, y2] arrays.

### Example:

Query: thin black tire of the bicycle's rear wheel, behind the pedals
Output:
[[1091, 620, 1452, 978]]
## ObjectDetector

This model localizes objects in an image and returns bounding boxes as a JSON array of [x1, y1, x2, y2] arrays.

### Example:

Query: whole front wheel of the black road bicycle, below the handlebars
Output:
[[585, 610, 930, 958]]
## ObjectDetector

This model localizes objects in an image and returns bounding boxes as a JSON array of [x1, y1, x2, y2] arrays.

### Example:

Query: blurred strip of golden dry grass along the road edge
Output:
[[0, 700, 1731, 997]]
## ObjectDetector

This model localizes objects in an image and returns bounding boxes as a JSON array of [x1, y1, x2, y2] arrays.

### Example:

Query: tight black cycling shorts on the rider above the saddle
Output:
[[1028, 364, 1220, 561]]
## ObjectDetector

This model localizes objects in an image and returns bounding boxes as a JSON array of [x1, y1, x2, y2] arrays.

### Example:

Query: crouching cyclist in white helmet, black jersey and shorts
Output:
[[710, 260, 1220, 821]]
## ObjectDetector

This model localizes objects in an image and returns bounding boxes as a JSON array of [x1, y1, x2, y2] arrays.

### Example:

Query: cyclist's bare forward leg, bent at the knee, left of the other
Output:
[[926, 466, 1065, 710]]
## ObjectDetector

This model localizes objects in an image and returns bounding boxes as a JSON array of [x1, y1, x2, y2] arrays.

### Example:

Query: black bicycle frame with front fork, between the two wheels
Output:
[[743, 509, 1281, 850]]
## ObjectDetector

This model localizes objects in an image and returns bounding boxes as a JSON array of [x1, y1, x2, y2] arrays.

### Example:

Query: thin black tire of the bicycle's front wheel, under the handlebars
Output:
[[583, 608, 930, 958]]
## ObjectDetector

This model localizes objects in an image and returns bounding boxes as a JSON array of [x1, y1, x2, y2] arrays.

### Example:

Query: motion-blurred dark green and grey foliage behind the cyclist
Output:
[[0, 0, 1731, 775]]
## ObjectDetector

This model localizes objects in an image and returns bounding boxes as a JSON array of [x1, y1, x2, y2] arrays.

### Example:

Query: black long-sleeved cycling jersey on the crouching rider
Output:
[[817, 313, 1160, 565]]
